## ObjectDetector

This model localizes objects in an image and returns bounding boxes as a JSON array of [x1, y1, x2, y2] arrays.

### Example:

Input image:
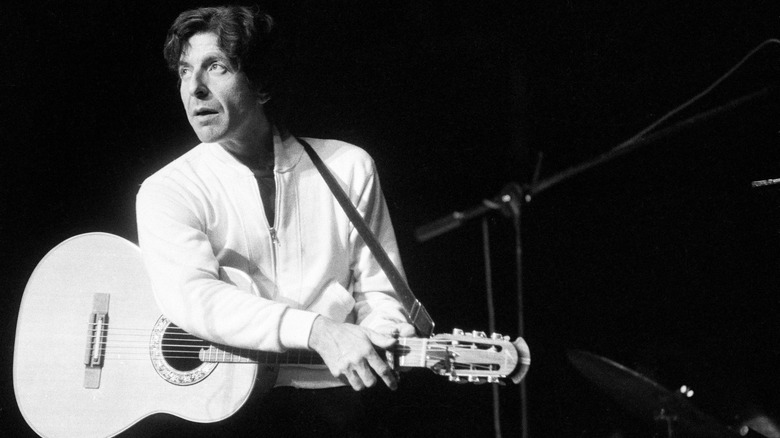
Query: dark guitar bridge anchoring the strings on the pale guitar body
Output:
[[84, 294, 110, 389]]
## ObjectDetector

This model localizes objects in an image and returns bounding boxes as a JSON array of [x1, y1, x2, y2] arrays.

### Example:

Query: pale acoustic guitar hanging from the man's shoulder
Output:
[[13, 233, 530, 438]]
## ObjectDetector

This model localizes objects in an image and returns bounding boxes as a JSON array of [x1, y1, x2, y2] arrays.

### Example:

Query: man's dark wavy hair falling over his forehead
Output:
[[163, 6, 282, 101]]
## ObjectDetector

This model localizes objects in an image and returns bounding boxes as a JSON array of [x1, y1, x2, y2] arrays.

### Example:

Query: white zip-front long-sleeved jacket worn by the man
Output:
[[136, 135, 406, 386]]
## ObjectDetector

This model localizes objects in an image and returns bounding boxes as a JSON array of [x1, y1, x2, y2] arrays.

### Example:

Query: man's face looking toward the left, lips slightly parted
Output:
[[179, 32, 266, 151]]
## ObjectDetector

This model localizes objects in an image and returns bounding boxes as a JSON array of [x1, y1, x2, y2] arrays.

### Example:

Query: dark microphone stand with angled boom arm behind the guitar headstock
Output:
[[415, 86, 778, 438]]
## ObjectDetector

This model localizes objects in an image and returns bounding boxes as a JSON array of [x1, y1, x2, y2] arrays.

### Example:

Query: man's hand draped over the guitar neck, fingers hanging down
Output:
[[309, 316, 398, 391]]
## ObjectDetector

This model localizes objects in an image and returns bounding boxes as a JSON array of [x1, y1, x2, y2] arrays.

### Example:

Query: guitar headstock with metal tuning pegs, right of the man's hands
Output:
[[414, 329, 531, 383]]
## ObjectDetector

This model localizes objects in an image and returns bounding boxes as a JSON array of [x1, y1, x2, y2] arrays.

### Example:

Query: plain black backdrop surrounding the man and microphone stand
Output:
[[0, 0, 780, 437]]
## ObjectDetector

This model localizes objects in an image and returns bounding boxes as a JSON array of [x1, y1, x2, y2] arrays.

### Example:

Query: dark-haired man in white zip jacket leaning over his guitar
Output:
[[136, 7, 414, 434]]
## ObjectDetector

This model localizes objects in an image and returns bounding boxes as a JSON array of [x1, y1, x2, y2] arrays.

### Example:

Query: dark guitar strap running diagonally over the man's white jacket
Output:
[[297, 138, 434, 337]]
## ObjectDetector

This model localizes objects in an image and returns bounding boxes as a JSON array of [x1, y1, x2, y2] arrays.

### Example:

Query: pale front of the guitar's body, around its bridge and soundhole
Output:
[[13, 233, 260, 438]]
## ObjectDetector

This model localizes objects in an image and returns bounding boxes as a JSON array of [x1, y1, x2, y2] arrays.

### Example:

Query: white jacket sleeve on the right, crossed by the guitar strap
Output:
[[350, 161, 408, 330]]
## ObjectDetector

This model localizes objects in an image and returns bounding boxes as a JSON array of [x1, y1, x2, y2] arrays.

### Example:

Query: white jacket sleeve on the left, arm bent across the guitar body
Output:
[[136, 181, 316, 351]]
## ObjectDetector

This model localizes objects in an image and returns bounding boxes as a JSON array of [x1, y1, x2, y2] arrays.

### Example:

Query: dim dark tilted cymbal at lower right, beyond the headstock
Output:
[[568, 350, 741, 438]]
